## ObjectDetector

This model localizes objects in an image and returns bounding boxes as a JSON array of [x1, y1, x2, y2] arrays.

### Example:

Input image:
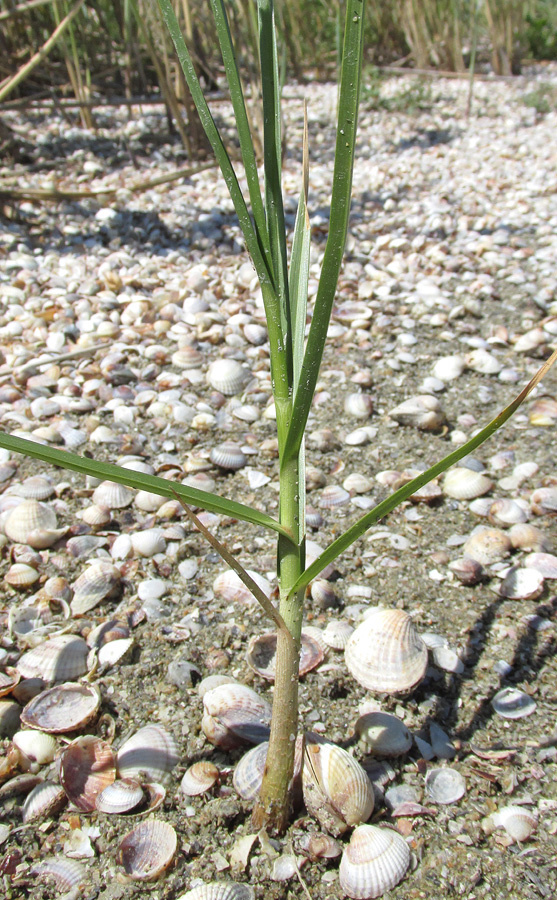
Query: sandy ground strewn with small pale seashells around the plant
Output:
[[0, 68, 557, 900]]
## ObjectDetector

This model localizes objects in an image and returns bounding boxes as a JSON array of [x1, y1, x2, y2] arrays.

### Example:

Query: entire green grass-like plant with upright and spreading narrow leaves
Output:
[[0, 0, 557, 831]]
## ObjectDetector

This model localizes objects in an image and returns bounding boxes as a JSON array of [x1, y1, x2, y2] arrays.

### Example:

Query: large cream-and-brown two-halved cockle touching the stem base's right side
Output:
[[302, 735, 373, 837]]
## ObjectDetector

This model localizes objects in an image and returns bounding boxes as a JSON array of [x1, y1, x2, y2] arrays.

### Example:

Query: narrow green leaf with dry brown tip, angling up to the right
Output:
[[289, 350, 557, 597]]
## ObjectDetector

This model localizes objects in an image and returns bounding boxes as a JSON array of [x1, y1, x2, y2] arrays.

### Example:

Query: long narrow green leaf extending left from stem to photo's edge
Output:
[[0, 432, 291, 539]]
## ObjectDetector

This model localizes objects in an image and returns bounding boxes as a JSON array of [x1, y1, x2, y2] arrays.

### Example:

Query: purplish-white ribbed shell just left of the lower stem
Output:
[[201, 684, 271, 750]]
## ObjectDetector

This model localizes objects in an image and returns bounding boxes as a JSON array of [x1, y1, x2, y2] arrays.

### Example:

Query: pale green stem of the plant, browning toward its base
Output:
[[252, 454, 305, 832]]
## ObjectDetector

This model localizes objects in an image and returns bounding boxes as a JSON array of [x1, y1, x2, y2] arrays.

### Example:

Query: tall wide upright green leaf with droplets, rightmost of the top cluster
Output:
[[284, 0, 365, 457]]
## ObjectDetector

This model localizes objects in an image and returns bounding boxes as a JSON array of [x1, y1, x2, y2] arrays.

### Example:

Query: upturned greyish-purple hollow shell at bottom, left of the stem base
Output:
[[118, 819, 178, 881]]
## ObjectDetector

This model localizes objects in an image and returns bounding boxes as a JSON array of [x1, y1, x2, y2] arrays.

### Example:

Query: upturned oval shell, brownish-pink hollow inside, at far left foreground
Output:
[[21, 682, 101, 734]]
